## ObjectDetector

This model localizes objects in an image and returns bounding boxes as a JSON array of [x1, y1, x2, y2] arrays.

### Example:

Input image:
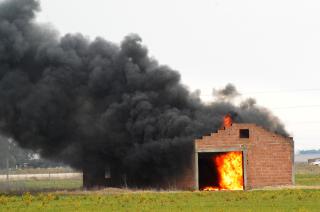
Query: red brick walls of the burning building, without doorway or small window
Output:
[[177, 123, 294, 189]]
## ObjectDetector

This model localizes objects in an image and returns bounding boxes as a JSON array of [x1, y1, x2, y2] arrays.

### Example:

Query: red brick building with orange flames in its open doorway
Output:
[[177, 123, 294, 190]]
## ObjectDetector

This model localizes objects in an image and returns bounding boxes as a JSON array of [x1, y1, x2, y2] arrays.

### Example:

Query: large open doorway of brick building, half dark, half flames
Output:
[[198, 151, 244, 191]]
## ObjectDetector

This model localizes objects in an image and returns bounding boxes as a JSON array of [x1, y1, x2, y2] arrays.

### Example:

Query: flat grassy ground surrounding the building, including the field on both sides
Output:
[[0, 164, 320, 211]]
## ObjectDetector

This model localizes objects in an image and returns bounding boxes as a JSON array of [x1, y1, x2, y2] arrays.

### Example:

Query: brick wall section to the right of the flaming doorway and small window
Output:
[[246, 127, 294, 188]]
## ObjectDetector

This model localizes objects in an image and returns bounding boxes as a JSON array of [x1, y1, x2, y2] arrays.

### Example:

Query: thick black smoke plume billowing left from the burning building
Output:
[[0, 0, 287, 186]]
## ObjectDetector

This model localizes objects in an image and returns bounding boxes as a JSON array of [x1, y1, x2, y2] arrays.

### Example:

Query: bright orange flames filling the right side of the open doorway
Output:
[[203, 152, 243, 191]]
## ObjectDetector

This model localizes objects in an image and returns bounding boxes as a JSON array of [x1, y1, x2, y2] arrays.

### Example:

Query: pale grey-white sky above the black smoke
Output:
[[38, 0, 320, 149]]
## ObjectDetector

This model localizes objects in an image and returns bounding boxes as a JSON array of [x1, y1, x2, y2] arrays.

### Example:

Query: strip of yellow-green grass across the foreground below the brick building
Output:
[[0, 190, 320, 211]]
